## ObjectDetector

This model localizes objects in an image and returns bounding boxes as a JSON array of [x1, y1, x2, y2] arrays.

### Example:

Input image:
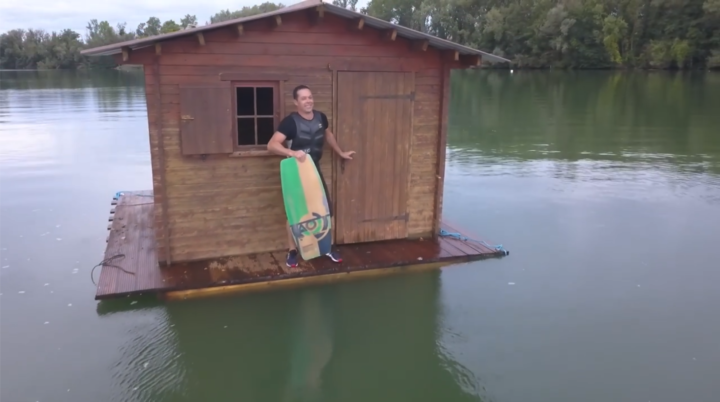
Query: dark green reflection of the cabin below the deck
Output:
[[98, 272, 483, 401]]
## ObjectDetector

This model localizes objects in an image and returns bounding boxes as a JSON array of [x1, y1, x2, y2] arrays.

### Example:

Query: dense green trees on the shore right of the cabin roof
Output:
[[362, 0, 720, 68]]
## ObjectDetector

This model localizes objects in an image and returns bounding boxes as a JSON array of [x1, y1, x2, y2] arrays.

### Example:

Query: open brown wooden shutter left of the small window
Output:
[[180, 85, 233, 155]]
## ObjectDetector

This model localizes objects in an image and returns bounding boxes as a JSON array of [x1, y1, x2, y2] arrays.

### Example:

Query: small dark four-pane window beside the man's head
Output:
[[233, 82, 280, 149]]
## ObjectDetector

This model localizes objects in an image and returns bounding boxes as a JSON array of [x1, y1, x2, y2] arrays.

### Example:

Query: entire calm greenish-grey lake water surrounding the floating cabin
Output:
[[0, 71, 720, 402]]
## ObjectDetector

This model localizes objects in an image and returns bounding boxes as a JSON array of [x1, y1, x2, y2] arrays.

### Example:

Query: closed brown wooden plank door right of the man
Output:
[[335, 72, 415, 244]]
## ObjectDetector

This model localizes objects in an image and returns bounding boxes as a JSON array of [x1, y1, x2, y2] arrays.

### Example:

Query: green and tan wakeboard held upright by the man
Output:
[[280, 156, 332, 260]]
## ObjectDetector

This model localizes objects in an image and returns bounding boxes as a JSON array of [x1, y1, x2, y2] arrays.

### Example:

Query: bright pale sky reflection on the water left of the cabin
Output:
[[0, 70, 150, 205]]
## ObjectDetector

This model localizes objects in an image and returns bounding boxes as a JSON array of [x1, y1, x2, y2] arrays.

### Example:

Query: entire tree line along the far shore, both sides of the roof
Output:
[[0, 0, 720, 69]]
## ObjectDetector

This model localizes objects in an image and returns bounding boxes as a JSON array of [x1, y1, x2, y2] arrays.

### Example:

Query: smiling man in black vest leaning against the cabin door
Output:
[[267, 85, 355, 267]]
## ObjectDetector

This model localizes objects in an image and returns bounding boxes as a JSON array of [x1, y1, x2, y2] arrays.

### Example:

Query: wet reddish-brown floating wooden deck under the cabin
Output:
[[95, 191, 506, 300]]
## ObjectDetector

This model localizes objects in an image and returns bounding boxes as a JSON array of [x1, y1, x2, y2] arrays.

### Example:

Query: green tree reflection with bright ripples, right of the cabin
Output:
[[447, 71, 720, 203]]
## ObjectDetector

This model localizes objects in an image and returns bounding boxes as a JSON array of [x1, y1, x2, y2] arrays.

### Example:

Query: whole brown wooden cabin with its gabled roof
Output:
[[83, 0, 508, 300]]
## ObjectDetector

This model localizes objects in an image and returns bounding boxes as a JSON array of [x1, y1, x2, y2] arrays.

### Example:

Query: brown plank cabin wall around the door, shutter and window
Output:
[[134, 13, 442, 261]]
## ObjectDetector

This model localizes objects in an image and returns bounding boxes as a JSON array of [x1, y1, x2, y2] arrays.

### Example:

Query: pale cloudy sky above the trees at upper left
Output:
[[0, 0, 368, 38]]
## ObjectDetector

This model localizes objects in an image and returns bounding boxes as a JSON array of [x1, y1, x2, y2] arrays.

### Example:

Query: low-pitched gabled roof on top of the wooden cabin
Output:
[[80, 0, 510, 62]]
